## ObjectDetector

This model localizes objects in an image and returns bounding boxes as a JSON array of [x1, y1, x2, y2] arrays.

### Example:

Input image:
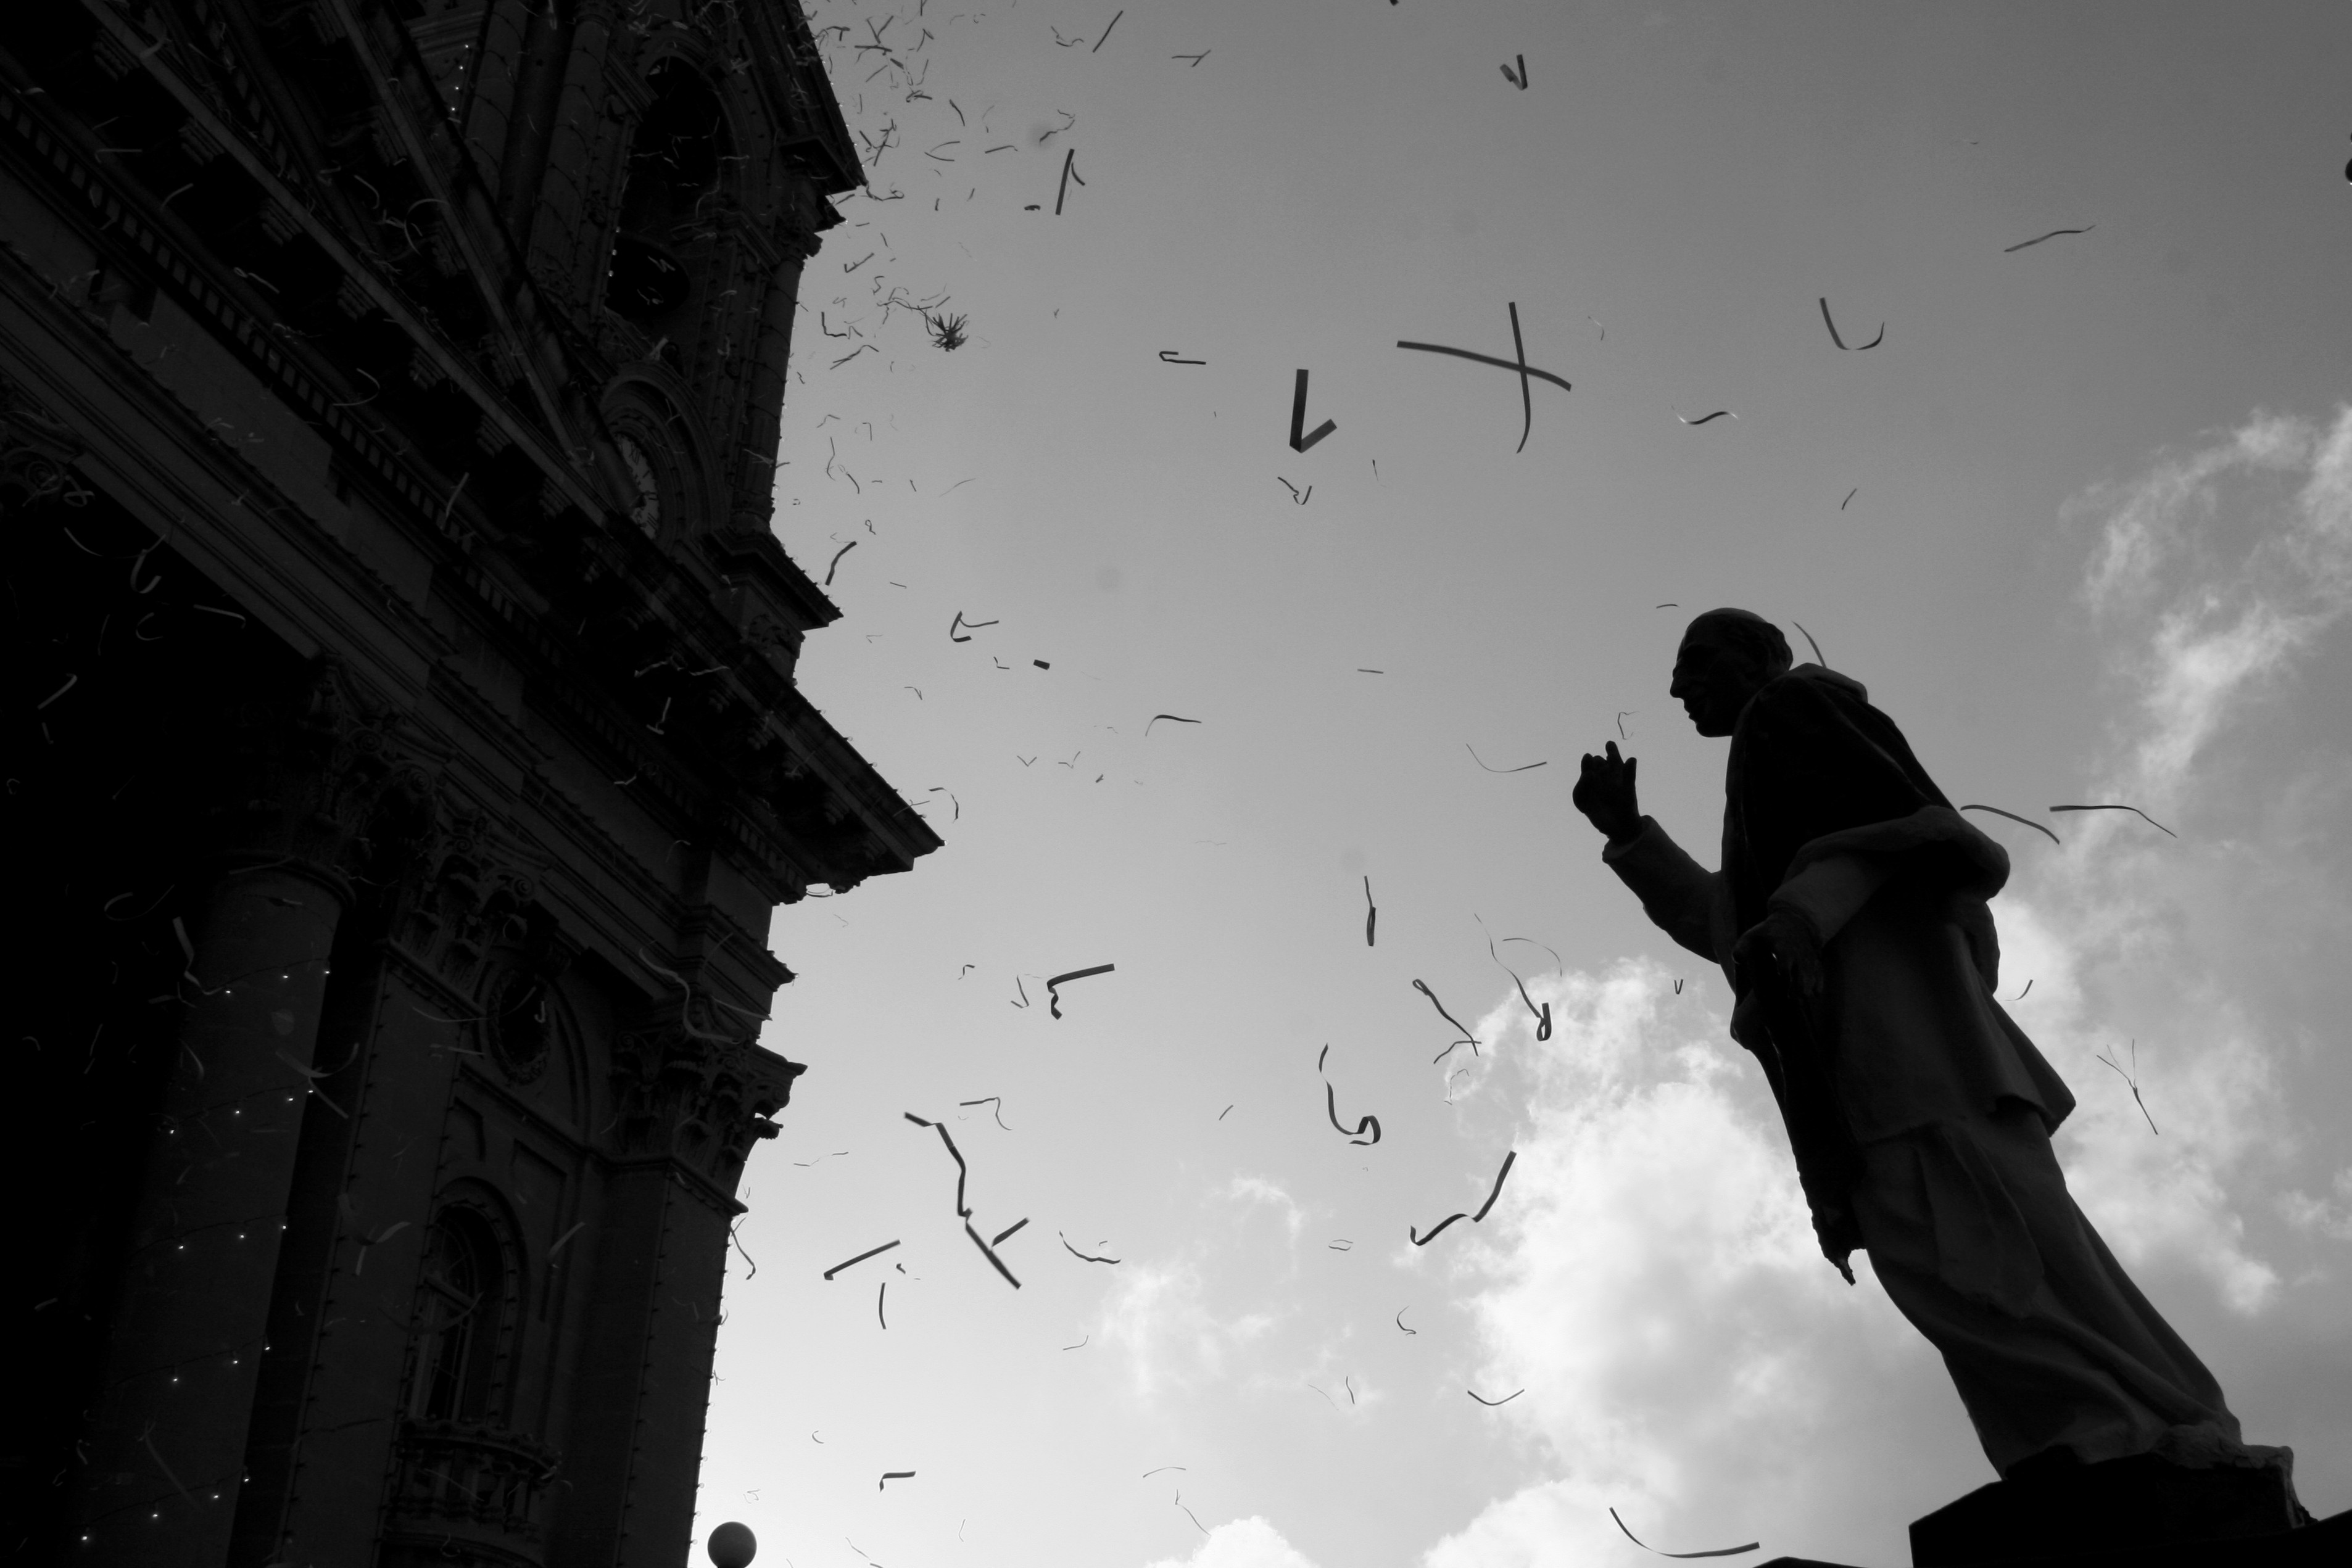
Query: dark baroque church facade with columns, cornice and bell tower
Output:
[[0, 0, 938, 1568]]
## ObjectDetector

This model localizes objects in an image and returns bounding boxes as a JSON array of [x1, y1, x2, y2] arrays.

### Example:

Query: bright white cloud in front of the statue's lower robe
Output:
[[1425, 959, 1973, 1568]]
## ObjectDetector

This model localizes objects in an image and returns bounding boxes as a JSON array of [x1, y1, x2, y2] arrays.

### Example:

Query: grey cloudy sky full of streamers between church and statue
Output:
[[701, 0, 2352, 1568]]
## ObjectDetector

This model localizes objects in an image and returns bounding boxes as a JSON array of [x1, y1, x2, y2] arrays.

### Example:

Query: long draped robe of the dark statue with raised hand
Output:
[[1602, 666, 2274, 1474]]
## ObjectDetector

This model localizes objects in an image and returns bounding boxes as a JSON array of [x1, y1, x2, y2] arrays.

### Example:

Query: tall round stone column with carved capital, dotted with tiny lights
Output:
[[75, 663, 435, 1568]]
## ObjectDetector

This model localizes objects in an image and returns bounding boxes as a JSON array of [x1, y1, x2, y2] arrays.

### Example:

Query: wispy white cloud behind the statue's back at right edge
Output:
[[1997, 409, 2352, 1314]]
